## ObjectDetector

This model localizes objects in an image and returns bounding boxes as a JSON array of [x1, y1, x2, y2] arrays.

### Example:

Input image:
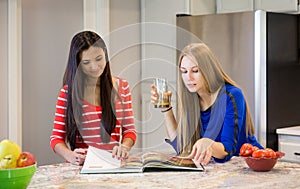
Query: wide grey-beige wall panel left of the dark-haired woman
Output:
[[22, 0, 83, 165]]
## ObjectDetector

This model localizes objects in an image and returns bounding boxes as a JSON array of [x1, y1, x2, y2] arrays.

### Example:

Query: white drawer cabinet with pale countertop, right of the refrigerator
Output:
[[276, 126, 300, 163]]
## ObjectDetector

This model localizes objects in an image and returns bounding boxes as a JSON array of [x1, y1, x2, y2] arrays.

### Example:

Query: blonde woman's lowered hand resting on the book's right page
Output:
[[188, 138, 215, 165]]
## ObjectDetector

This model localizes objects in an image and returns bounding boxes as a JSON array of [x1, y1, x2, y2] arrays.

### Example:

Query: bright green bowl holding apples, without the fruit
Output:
[[0, 163, 37, 189]]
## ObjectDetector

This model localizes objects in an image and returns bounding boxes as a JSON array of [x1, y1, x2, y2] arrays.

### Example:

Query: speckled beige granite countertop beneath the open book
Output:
[[28, 157, 300, 189]]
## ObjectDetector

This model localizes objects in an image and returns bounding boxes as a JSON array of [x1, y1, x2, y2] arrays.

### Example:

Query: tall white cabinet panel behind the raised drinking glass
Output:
[[141, 0, 190, 152]]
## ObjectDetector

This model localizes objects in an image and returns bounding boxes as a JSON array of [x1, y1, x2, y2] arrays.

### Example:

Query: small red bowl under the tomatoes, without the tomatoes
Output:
[[244, 152, 284, 172]]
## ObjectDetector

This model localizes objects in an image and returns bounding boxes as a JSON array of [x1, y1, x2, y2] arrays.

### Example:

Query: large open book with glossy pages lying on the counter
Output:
[[80, 146, 204, 174]]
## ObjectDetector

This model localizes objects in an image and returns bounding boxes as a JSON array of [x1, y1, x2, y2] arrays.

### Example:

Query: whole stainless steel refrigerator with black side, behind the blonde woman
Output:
[[177, 11, 300, 150]]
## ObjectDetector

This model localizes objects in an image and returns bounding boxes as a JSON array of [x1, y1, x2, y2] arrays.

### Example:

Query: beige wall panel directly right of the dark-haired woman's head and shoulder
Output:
[[109, 0, 142, 148]]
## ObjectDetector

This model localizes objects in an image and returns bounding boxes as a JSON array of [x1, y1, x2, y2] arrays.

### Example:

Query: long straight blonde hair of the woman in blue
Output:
[[177, 43, 254, 155]]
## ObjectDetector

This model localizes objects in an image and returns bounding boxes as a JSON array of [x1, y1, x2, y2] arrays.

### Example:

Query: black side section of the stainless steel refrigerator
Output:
[[266, 12, 300, 149]]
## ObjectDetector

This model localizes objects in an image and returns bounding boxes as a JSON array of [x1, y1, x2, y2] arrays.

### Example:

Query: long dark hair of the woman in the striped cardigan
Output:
[[63, 31, 117, 150]]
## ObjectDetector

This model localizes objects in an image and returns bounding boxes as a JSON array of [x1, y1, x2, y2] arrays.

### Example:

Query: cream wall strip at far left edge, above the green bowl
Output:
[[0, 0, 22, 146]]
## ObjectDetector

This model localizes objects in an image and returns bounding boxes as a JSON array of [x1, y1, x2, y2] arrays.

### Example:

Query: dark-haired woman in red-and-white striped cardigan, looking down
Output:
[[50, 31, 136, 165]]
